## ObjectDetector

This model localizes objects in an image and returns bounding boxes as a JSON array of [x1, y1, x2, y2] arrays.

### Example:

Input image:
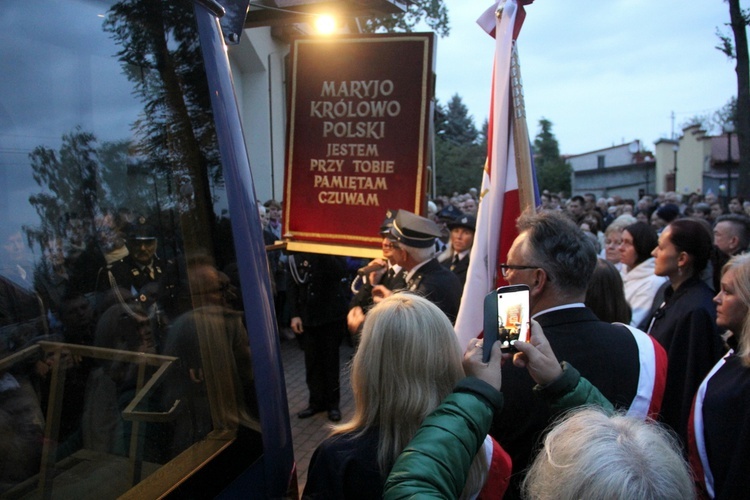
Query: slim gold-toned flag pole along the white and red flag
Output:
[[510, 40, 536, 212]]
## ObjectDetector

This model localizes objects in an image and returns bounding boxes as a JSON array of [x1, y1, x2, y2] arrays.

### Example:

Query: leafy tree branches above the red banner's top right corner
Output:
[[360, 0, 450, 37]]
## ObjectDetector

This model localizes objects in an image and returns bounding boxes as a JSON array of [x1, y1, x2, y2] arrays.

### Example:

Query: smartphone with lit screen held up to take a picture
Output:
[[482, 285, 530, 363]]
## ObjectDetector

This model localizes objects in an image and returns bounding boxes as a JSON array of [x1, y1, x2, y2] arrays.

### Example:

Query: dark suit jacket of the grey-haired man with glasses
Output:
[[490, 307, 652, 498]]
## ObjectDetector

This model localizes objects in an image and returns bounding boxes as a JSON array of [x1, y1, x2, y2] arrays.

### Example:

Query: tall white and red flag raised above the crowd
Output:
[[455, 0, 534, 346]]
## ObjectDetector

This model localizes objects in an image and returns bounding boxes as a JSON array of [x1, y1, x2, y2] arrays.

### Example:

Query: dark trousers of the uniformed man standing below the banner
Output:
[[301, 319, 346, 410]]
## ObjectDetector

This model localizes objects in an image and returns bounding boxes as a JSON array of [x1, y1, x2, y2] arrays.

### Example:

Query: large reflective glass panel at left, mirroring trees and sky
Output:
[[0, 0, 260, 498]]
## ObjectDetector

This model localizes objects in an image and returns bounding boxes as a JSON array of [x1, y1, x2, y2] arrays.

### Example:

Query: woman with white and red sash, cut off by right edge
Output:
[[689, 254, 750, 498]]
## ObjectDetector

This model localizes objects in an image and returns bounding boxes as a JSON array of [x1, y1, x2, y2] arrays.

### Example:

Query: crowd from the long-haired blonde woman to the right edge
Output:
[[296, 188, 750, 498]]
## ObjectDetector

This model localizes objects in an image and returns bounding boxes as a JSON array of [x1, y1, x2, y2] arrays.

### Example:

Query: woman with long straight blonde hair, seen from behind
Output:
[[303, 293, 510, 499]]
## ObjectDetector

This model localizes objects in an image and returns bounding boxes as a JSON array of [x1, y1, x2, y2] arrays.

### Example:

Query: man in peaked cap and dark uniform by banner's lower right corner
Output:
[[372, 210, 463, 322]]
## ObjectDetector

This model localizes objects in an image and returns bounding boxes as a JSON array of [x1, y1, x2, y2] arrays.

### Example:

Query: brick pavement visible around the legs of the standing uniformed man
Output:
[[281, 334, 354, 495]]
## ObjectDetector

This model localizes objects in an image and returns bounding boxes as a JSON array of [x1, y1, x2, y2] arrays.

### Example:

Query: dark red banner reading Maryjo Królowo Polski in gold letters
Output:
[[283, 33, 434, 255]]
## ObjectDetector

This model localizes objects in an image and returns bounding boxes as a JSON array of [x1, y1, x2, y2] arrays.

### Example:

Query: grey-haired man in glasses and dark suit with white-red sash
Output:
[[491, 210, 666, 498]]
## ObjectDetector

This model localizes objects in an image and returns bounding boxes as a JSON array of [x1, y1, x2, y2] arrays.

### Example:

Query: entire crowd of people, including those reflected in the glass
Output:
[[0, 186, 750, 498]]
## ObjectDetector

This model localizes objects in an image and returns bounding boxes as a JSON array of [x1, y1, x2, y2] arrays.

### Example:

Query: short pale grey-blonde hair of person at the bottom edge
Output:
[[522, 407, 696, 500]]
